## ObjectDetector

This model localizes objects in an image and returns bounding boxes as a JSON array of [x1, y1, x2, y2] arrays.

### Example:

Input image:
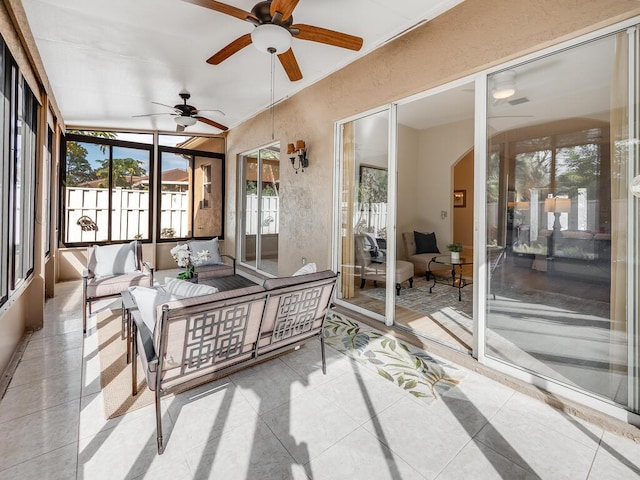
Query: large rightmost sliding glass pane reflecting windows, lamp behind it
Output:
[[484, 31, 638, 409]]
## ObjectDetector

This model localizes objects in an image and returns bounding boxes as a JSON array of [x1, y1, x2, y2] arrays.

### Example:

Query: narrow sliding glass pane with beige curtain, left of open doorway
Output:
[[337, 110, 395, 321]]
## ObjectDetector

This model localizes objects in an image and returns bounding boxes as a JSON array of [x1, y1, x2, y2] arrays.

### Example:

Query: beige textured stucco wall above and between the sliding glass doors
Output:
[[227, 0, 640, 274]]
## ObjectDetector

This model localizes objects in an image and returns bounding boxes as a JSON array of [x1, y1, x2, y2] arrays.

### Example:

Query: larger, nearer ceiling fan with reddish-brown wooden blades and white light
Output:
[[183, 0, 362, 82]]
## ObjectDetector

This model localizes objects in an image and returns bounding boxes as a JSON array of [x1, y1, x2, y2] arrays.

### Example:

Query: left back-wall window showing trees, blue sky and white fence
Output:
[[61, 132, 153, 246]]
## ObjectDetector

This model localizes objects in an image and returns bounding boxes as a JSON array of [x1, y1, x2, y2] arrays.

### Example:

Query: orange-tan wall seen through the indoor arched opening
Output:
[[452, 150, 474, 249]]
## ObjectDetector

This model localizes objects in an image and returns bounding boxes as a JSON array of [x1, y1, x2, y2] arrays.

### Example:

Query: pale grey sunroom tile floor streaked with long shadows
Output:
[[0, 282, 640, 480]]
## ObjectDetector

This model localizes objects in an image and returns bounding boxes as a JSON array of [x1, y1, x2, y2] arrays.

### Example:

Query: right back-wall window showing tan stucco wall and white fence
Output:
[[158, 146, 224, 240]]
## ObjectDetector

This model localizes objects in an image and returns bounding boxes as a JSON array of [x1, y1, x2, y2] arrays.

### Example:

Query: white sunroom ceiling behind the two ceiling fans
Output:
[[23, 0, 462, 133]]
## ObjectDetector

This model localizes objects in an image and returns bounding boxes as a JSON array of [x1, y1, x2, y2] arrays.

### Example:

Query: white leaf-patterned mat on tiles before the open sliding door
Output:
[[324, 314, 465, 403]]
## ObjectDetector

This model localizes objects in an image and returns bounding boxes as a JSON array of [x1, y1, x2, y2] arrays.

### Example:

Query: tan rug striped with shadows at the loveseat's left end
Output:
[[96, 308, 154, 418]]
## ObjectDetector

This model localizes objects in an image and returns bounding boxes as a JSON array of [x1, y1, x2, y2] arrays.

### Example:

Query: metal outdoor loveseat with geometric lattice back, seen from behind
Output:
[[124, 270, 336, 454]]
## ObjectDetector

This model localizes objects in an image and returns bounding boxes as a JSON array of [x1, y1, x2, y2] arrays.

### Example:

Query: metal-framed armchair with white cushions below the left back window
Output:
[[82, 241, 154, 333]]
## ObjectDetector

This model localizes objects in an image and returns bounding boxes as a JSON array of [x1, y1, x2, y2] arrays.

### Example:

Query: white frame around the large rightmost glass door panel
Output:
[[473, 17, 640, 424]]
